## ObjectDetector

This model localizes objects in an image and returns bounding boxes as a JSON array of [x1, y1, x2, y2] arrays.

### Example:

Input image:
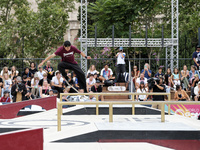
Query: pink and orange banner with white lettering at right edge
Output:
[[165, 105, 200, 119]]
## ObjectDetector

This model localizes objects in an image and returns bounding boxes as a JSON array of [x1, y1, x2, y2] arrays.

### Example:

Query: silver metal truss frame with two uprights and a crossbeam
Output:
[[80, 0, 179, 73]]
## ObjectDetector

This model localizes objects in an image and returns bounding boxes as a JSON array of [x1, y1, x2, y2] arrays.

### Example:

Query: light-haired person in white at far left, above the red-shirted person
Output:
[[1, 73, 12, 99]]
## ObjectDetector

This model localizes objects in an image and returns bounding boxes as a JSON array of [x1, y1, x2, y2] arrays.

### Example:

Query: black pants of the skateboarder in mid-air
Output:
[[58, 61, 87, 92]]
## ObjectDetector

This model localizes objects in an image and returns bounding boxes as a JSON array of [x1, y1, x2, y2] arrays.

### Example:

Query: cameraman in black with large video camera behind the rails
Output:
[[151, 78, 165, 109]]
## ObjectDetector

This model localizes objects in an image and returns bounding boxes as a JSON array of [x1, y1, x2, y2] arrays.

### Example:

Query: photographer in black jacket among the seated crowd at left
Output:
[[11, 76, 27, 102]]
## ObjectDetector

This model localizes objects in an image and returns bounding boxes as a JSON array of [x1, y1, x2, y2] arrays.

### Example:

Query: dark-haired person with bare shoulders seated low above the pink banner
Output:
[[174, 85, 190, 101]]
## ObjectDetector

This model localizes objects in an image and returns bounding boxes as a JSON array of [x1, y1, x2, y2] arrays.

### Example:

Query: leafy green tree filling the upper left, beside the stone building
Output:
[[0, 0, 74, 58]]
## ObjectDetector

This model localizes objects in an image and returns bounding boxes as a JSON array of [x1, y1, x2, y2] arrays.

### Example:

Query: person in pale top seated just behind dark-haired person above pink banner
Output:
[[181, 65, 190, 91]]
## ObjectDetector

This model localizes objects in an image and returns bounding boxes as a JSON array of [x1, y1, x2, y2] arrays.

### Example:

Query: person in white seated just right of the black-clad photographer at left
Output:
[[31, 73, 40, 98]]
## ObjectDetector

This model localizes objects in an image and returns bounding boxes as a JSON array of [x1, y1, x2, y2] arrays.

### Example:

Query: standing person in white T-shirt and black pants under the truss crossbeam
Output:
[[116, 47, 126, 82]]
